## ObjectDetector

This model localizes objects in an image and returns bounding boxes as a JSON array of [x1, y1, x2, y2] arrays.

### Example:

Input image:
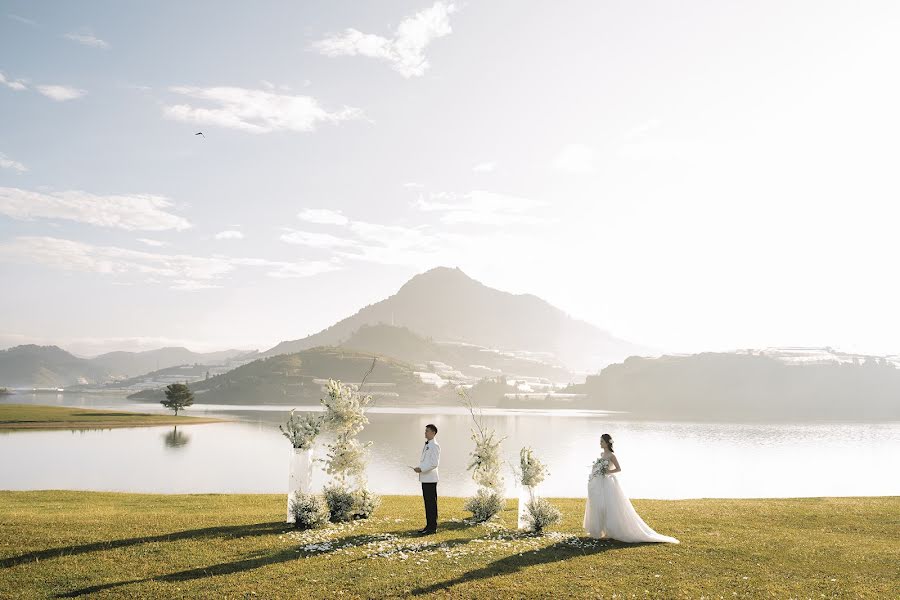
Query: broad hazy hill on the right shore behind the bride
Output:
[[567, 353, 900, 421]]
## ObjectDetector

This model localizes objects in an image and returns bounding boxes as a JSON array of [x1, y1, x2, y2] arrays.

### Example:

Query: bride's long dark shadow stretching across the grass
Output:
[[412, 538, 652, 596]]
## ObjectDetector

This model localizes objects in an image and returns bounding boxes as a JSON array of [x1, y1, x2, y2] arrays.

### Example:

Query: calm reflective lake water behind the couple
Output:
[[0, 394, 900, 498]]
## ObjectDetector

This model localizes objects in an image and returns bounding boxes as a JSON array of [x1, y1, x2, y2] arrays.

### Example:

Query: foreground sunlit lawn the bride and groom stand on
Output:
[[0, 491, 900, 599]]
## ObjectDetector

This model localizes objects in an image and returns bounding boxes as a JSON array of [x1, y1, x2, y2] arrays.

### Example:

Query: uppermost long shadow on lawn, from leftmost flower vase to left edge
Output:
[[0, 522, 290, 569]]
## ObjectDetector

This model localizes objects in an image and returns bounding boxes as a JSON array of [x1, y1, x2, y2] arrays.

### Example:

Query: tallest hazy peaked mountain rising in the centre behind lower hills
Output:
[[264, 267, 648, 370]]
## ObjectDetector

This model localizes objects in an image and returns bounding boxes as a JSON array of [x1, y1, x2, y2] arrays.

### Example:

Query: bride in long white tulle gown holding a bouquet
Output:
[[584, 433, 678, 544]]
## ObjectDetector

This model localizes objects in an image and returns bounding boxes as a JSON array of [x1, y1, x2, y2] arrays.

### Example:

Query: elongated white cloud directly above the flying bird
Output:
[[163, 87, 362, 133]]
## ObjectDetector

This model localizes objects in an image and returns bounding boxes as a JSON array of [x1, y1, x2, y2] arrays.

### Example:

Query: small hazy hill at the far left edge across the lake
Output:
[[0, 344, 109, 388]]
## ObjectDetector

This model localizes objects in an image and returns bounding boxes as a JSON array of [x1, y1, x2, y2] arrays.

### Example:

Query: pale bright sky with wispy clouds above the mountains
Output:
[[0, 0, 900, 355]]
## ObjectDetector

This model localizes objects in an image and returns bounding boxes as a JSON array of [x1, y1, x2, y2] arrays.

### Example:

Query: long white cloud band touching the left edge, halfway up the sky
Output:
[[0, 187, 191, 231]]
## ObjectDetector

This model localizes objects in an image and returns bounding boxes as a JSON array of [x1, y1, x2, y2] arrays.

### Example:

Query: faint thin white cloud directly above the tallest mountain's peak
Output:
[[414, 190, 547, 225]]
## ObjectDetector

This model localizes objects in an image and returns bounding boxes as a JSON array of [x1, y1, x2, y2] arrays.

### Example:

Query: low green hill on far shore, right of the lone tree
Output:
[[129, 348, 455, 404]]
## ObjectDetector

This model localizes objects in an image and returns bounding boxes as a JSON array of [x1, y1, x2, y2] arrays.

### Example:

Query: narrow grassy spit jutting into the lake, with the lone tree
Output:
[[0, 404, 221, 432]]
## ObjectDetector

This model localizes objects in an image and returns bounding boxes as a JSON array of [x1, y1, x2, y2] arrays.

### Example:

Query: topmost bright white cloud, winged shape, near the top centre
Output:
[[313, 2, 457, 78]]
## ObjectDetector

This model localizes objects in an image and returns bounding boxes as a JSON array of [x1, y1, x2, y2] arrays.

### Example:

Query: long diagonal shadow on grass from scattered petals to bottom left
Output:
[[56, 523, 372, 598]]
